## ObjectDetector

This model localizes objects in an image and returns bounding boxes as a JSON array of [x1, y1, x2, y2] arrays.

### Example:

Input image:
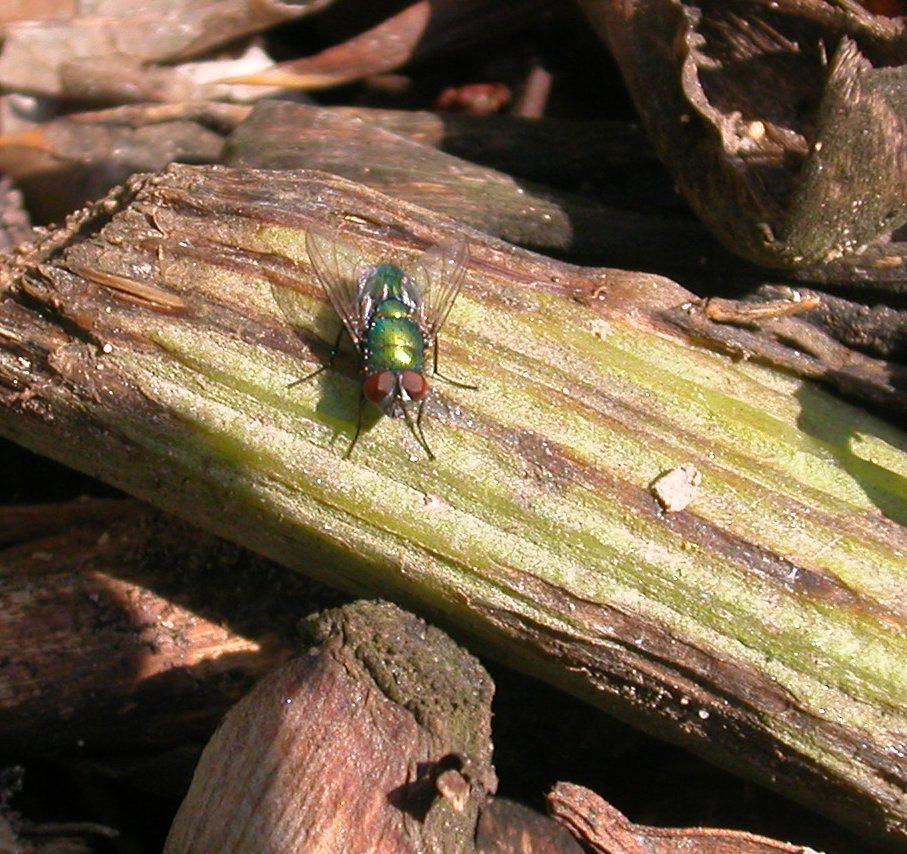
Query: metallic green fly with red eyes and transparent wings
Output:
[[284, 224, 476, 460]]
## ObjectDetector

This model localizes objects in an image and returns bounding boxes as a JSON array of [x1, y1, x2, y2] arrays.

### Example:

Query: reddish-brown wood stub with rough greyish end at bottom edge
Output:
[[164, 602, 496, 854]]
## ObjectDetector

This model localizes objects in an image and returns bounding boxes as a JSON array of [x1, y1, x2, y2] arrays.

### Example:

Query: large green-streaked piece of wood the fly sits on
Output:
[[0, 166, 907, 846]]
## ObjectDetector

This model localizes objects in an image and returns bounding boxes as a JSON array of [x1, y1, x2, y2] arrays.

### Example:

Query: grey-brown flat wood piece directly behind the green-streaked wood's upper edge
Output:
[[224, 102, 732, 266]]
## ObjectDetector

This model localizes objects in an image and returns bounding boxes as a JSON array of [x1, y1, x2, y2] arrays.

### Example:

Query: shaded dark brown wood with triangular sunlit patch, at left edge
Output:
[[0, 499, 334, 757]]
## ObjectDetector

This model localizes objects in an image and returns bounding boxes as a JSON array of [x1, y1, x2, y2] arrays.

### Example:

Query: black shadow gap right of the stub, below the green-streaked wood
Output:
[[484, 661, 885, 854]]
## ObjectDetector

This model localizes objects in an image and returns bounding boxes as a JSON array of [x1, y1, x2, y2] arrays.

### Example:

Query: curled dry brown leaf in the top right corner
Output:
[[583, 0, 907, 278]]
